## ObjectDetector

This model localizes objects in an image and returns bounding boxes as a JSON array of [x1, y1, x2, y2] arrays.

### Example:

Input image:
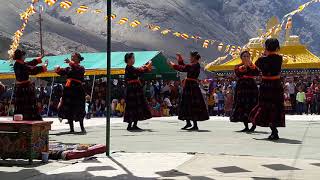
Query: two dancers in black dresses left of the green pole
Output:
[[13, 49, 86, 133]]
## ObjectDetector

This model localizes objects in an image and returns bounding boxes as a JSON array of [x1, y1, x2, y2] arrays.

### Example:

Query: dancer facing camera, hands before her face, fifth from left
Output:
[[230, 51, 259, 132]]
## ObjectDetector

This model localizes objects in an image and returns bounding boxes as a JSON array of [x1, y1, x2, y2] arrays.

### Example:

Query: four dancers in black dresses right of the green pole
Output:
[[124, 38, 285, 140]]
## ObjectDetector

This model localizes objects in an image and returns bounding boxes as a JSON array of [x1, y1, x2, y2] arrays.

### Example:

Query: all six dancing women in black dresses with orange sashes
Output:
[[8, 39, 285, 140]]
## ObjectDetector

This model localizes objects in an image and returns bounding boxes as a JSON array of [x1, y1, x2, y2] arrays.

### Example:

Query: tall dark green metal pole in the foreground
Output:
[[106, 0, 111, 156]]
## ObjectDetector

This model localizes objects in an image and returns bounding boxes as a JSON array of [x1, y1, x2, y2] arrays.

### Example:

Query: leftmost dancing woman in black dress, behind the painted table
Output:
[[13, 49, 48, 121]]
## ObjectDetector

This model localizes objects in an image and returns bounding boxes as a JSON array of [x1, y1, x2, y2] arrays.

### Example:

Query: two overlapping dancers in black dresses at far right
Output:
[[230, 39, 285, 140]]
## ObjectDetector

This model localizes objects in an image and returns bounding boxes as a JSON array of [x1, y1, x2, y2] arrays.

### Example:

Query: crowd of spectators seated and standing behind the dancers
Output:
[[0, 73, 320, 119]]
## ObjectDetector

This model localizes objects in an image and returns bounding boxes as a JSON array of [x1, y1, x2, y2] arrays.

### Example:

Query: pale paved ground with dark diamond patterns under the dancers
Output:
[[0, 116, 320, 180]]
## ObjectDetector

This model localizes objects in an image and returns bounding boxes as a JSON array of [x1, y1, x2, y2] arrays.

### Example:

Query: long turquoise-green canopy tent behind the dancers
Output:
[[0, 51, 177, 80]]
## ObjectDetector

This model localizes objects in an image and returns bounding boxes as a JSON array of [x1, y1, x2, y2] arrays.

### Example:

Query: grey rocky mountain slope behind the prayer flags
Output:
[[0, 0, 320, 62]]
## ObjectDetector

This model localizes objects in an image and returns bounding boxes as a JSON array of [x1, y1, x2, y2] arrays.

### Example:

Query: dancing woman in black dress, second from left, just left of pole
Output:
[[55, 53, 86, 133]]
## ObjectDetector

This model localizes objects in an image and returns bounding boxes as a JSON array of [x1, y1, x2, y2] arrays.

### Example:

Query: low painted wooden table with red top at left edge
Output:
[[0, 121, 52, 163]]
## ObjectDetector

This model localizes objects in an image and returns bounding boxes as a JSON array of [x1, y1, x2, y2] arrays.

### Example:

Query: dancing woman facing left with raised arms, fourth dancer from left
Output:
[[169, 52, 209, 131]]
